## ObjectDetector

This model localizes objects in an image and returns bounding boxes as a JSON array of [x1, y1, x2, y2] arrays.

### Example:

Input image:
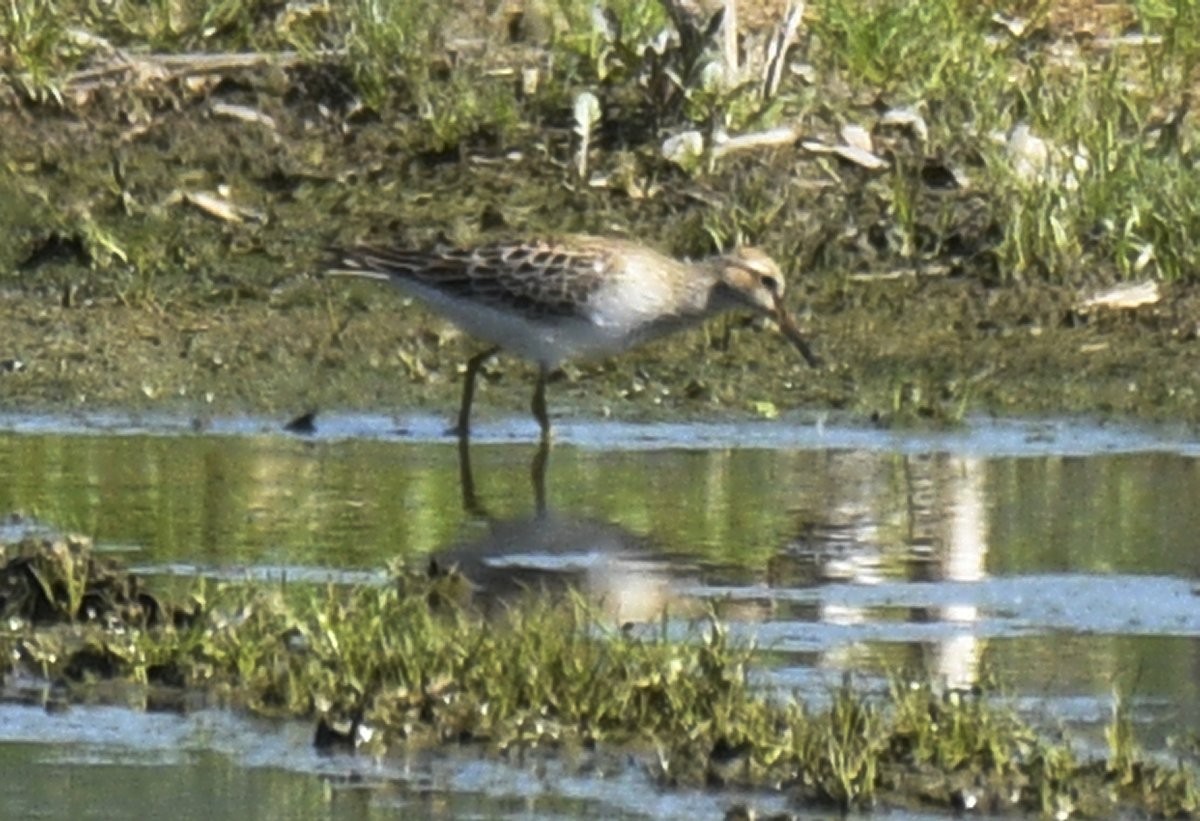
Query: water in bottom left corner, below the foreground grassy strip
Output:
[[0, 705, 739, 821]]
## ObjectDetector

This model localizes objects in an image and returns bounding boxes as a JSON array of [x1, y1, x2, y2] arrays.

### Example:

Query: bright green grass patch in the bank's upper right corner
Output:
[[814, 0, 1200, 281]]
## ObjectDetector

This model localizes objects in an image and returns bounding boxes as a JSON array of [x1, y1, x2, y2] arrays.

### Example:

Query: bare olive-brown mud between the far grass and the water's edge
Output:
[[0, 79, 1200, 424]]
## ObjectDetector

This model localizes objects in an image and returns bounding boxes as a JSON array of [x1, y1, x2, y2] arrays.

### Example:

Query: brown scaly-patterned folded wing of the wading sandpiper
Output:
[[336, 241, 612, 318]]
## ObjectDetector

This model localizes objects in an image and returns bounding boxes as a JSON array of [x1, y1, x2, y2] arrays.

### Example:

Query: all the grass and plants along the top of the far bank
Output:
[[0, 0, 1200, 291]]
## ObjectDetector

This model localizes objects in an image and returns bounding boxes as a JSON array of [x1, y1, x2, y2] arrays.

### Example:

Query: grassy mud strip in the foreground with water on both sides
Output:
[[0, 539, 1200, 815]]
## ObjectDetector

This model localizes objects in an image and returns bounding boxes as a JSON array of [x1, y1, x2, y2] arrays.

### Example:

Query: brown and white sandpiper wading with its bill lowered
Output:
[[328, 235, 820, 439]]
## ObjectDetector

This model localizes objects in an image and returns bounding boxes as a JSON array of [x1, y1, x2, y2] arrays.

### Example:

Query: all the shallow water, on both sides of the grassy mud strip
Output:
[[0, 417, 1200, 817]]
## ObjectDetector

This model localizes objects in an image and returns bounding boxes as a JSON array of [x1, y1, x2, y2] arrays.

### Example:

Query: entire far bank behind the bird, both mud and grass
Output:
[[0, 0, 1200, 421]]
